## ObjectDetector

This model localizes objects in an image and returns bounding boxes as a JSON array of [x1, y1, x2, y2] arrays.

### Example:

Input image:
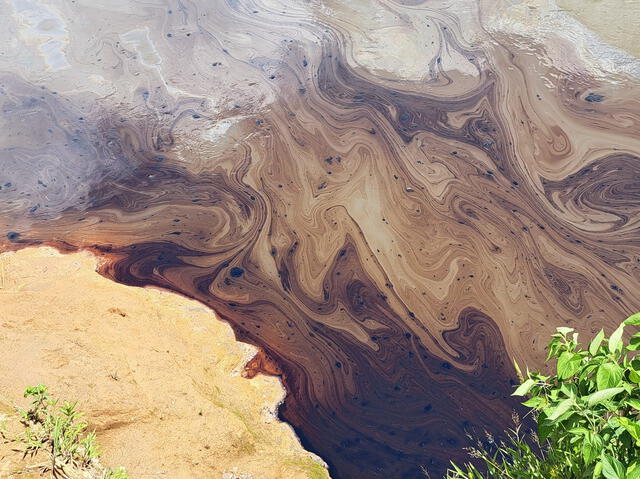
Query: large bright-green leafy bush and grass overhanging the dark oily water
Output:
[[446, 313, 640, 479]]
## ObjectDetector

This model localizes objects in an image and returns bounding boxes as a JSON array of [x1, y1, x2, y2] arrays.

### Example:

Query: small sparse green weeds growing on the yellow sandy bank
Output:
[[0, 385, 129, 479]]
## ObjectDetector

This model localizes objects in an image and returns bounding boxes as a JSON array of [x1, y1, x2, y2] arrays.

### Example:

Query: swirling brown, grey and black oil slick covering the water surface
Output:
[[0, 0, 640, 478]]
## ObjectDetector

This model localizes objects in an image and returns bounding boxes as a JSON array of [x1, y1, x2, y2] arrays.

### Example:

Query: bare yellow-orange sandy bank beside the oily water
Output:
[[0, 248, 328, 479]]
